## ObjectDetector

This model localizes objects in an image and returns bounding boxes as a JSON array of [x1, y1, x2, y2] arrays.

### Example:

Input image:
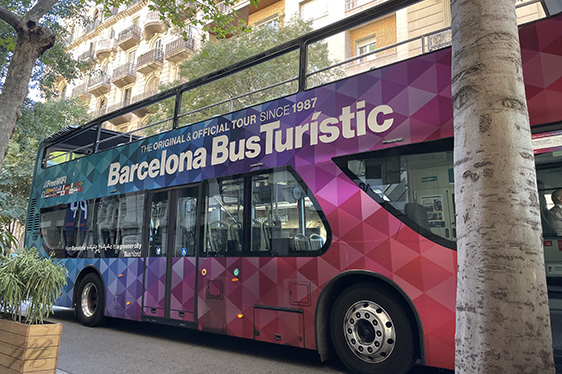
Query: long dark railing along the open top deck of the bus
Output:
[[43, 0, 549, 165]]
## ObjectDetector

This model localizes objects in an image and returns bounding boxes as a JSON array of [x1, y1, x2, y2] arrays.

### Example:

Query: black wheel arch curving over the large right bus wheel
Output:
[[315, 270, 425, 364]]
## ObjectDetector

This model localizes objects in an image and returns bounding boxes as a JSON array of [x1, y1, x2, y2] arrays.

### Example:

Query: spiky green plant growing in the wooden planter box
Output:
[[0, 248, 68, 324]]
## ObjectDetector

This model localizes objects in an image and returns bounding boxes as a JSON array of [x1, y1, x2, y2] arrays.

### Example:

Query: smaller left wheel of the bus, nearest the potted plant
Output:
[[75, 273, 105, 326]]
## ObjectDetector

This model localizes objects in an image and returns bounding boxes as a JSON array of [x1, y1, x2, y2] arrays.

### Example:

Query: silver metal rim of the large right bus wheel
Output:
[[343, 300, 396, 364]]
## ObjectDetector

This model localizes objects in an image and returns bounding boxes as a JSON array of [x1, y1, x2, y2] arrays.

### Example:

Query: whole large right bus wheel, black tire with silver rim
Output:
[[330, 283, 416, 374]]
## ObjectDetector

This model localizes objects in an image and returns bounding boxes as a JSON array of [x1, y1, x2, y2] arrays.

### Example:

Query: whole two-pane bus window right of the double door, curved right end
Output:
[[202, 168, 329, 256]]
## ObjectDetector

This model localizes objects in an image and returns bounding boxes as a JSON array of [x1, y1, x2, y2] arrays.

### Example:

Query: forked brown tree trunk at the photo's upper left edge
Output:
[[0, 18, 55, 168]]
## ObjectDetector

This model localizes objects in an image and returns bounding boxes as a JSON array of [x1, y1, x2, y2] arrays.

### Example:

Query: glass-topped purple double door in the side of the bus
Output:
[[143, 185, 199, 323]]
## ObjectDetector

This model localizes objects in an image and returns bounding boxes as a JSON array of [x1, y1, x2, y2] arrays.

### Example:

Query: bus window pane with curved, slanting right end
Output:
[[250, 170, 327, 256]]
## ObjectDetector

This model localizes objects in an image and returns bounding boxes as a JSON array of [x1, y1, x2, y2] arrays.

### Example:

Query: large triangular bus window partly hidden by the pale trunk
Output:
[[336, 141, 456, 247]]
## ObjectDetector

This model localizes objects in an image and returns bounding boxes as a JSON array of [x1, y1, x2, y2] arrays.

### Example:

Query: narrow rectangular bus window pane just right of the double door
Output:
[[203, 178, 244, 256]]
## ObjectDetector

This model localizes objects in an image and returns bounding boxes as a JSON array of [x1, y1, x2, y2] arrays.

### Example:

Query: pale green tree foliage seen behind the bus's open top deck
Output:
[[143, 18, 344, 135]]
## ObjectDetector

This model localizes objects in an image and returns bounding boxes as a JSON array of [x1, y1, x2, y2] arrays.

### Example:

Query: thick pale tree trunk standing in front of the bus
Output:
[[452, 0, 554, 374]]
